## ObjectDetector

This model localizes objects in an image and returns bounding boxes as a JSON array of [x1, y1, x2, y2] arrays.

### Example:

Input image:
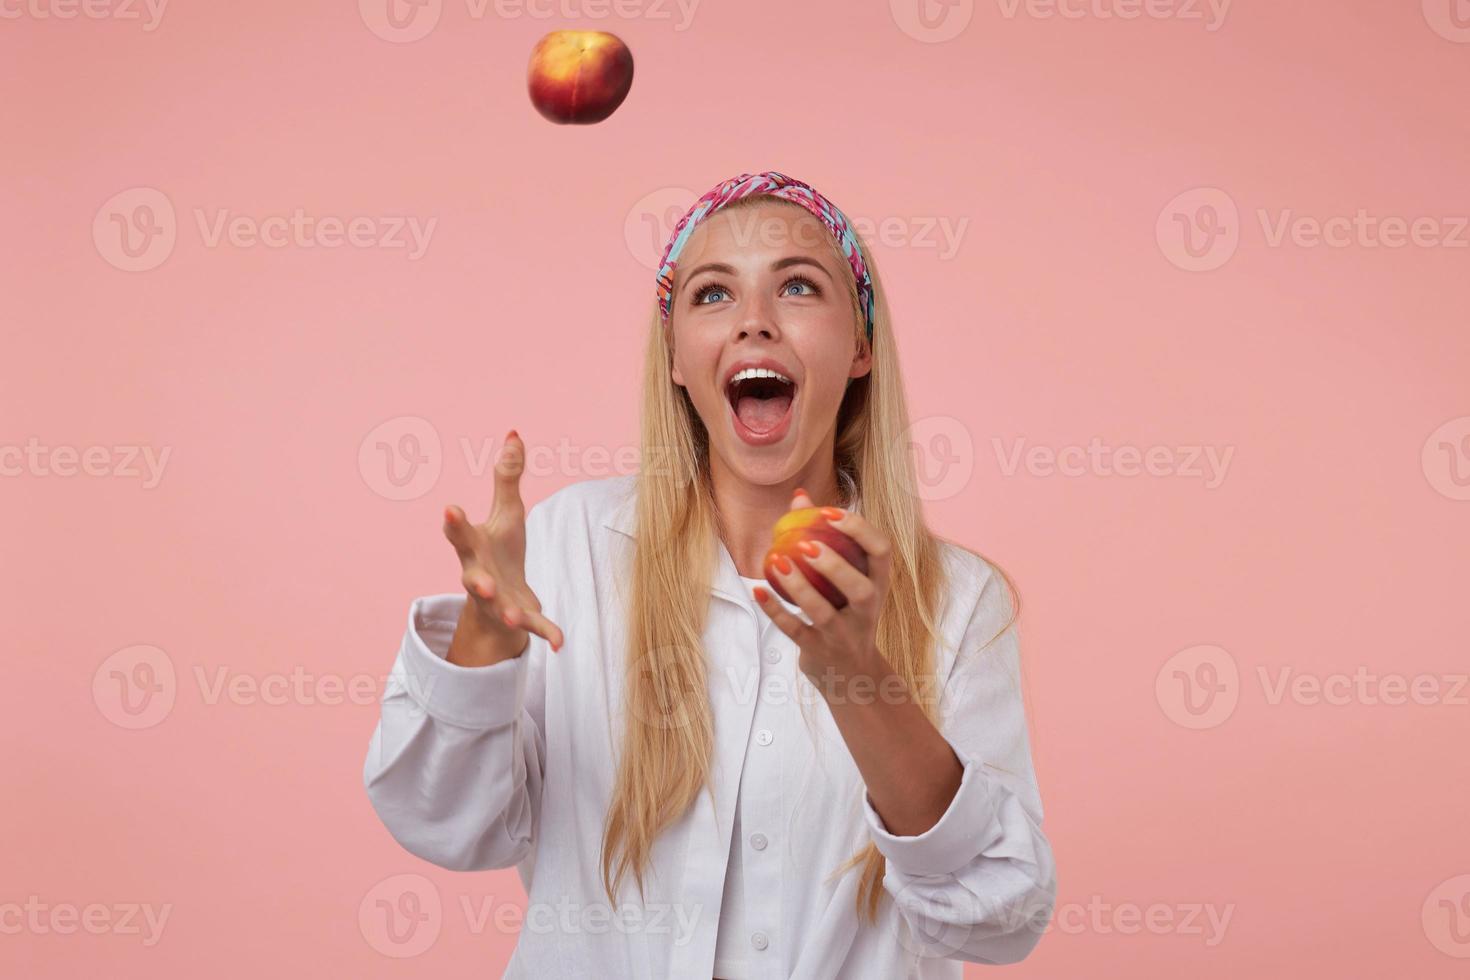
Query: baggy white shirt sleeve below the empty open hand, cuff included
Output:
[[363, 594, 545, 871]]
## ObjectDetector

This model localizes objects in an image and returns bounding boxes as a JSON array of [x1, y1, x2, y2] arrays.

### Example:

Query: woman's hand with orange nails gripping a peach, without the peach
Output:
[[754, 492, 892, 693]]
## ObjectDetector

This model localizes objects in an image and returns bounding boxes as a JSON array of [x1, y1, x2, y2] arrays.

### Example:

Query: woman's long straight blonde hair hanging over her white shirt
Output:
[[601, 195, 993, 921]]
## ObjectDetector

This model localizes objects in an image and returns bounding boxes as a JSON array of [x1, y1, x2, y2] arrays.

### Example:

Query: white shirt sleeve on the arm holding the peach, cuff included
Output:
[[863, 560, 1057, 964]]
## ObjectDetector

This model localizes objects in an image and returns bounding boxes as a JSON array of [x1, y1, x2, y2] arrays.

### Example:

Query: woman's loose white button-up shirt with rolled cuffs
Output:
[[363, 476, 1057, 980]]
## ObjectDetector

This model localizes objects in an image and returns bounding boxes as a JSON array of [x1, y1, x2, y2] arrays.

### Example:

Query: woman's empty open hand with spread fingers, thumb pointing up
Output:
[[444, 429, 563, 667]]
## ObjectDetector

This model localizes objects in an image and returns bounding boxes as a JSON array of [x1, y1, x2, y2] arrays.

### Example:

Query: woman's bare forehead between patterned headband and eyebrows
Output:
[[679, 200, 832, 269]]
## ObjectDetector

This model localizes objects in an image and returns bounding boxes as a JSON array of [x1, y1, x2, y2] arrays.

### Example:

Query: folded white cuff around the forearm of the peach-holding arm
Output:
[[863, 755, 998, 874]]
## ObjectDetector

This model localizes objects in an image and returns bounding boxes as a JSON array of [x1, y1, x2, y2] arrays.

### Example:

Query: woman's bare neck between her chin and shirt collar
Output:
[[710, 439, 842, 579]]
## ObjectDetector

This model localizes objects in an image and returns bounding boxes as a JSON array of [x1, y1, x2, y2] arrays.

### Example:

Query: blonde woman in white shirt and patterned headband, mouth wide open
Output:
[[365, 172, 1055, 980]]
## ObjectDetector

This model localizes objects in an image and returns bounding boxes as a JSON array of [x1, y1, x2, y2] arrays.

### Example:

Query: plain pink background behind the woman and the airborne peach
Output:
[[0, 0, 1470, 979]]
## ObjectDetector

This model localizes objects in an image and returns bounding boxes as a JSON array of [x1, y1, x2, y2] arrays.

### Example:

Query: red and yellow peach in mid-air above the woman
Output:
[[526, 31, 634, 123]]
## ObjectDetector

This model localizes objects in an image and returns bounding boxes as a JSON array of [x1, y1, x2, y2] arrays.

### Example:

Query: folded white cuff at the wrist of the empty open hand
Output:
[[398, 595, 531, 729]]
